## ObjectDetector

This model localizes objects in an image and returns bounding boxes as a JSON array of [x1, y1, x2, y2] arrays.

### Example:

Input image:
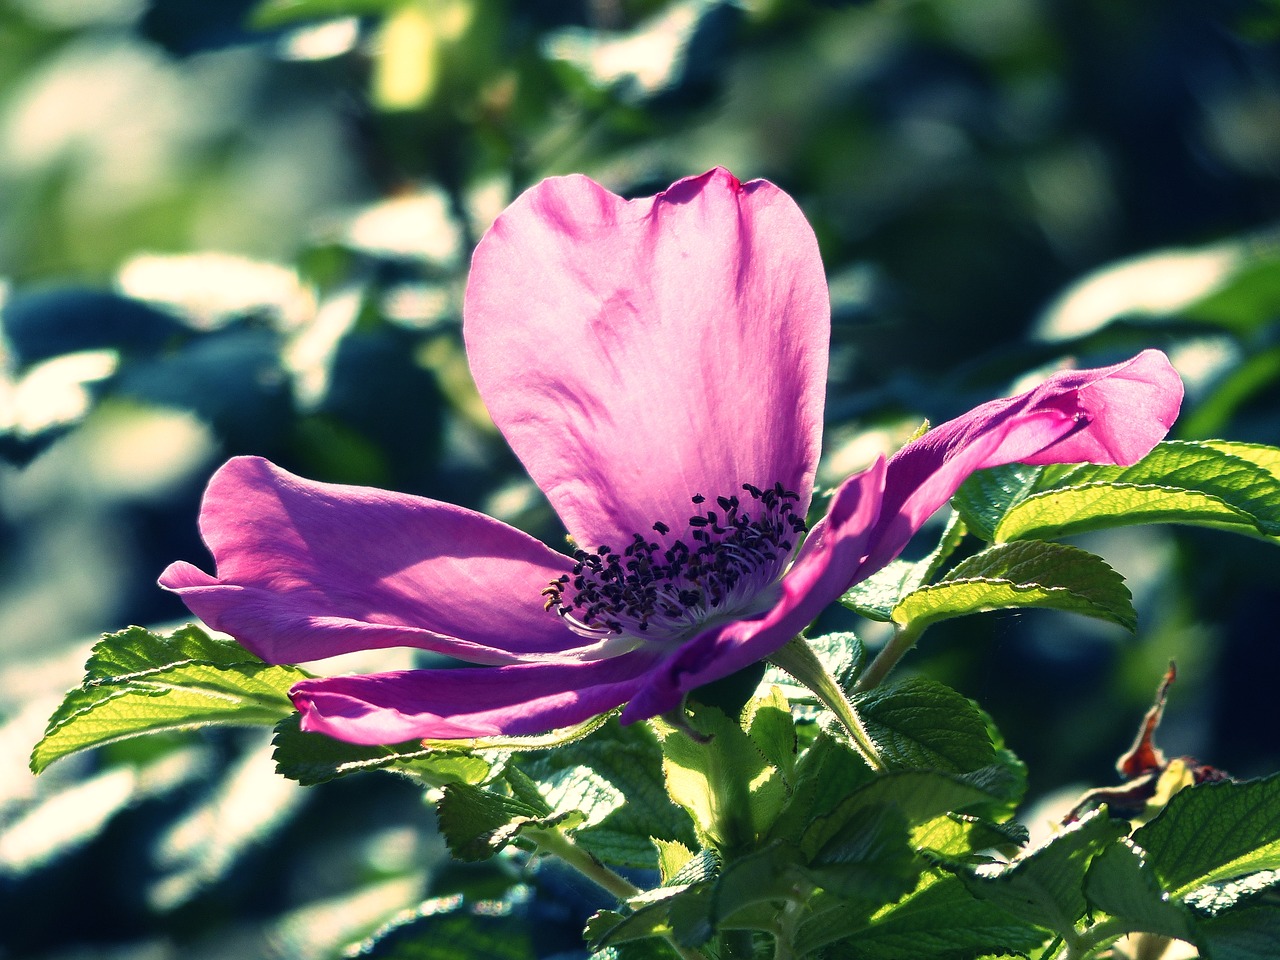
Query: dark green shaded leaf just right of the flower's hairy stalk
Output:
[[854, 677, 996, 773]]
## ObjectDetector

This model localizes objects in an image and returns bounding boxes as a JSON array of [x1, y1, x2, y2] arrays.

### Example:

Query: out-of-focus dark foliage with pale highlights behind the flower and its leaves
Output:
[[0, 0, 1280, 960]]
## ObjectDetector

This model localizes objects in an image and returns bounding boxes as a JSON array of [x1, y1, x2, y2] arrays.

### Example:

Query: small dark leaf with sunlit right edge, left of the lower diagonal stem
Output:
[[435, 783, 581, 860]]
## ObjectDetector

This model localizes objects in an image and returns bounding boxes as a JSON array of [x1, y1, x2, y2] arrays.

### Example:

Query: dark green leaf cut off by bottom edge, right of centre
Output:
[[796, 876, 1047, 960]]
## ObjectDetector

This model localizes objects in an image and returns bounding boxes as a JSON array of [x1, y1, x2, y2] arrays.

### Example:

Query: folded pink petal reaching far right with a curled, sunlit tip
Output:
[[851, 349, 1183, 582]]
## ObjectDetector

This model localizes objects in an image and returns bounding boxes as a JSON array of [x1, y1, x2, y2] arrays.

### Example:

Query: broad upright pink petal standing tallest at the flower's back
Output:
[[465, 169, 831, 547]]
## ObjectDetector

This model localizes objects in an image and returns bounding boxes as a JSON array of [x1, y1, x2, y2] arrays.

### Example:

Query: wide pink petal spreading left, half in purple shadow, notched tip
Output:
[[160, 457, 584, 663]]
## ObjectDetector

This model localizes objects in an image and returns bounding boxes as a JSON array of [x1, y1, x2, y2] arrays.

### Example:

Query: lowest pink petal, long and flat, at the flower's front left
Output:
[[289, 652, 653, 744]]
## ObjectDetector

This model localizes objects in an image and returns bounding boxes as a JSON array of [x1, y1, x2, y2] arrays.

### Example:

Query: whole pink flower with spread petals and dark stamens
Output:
[[160, 169, 1181, 744]]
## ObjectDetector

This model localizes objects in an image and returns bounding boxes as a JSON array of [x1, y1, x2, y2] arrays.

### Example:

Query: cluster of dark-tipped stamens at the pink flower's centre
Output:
[[543, 484, 806, 639]]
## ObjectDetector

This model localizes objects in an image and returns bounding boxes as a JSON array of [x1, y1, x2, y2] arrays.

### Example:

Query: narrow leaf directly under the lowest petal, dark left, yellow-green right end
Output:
[[273, 714, 492, 787]]
